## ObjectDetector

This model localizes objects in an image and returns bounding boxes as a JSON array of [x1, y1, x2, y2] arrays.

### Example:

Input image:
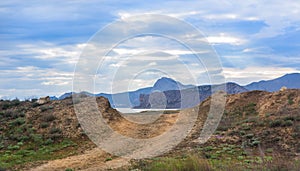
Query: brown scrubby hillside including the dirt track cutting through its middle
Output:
[[0, 89, 300, 170]]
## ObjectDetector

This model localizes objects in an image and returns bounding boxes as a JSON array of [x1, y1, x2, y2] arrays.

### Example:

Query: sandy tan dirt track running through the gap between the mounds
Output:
[[31, 110, 177, 171]]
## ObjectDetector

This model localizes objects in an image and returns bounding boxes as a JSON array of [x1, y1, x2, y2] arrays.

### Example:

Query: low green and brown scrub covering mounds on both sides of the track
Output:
[[0, 90, 300, 171]]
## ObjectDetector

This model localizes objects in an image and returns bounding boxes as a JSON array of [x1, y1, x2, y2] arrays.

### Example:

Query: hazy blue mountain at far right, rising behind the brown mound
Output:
[[244, 73, 300, 92]]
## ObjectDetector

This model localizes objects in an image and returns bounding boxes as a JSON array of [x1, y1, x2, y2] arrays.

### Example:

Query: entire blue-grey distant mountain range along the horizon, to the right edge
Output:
[[52, 73, 300, 108]]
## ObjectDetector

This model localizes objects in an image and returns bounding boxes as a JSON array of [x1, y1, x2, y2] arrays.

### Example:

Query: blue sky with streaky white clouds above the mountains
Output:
[[0, 0, 300, 99]]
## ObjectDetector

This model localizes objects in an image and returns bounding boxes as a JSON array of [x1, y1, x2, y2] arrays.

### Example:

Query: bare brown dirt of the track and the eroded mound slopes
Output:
[[0, 89, 300, 170]]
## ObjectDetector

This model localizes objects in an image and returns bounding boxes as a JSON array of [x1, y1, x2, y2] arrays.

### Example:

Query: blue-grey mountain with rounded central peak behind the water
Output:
[[58, 77, 248, 108]]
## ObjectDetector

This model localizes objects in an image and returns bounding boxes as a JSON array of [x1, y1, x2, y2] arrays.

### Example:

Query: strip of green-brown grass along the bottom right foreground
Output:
[[134, 154, 300, 171]]
